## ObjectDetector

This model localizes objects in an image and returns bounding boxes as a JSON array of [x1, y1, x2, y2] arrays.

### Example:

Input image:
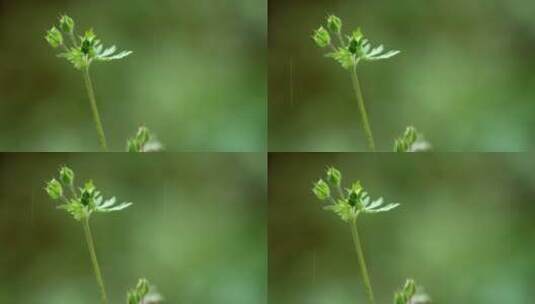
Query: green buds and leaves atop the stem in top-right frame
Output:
[[312, 15, 400, 69]]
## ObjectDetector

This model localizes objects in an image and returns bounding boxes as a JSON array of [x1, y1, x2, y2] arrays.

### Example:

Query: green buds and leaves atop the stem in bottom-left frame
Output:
[[45, 166, 132, 221]]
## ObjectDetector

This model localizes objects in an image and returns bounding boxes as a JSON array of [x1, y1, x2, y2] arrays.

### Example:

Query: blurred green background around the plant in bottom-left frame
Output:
[[0, 153, 267, 304]]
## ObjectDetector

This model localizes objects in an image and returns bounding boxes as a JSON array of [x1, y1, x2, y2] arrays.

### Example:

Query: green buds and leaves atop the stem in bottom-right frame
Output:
[[312, 167, 399, 222]]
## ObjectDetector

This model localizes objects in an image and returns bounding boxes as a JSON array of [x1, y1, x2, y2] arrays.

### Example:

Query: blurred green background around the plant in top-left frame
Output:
[[0, 0, 267, 152]]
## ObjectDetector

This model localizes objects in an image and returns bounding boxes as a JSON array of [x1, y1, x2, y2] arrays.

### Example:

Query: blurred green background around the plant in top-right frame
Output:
[[268, 0, 535, 152]]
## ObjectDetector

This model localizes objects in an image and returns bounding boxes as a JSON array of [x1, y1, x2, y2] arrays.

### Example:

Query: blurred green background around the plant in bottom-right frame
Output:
[[268, 153, 535, 304]]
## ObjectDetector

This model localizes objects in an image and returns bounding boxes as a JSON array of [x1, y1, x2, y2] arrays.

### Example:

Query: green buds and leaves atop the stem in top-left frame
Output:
[[45, 15, 132, 70]]
